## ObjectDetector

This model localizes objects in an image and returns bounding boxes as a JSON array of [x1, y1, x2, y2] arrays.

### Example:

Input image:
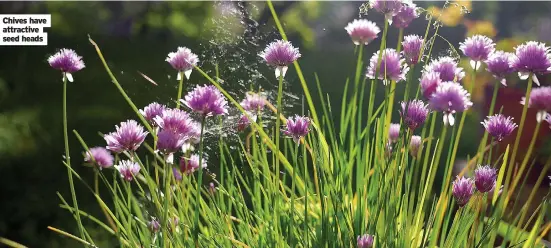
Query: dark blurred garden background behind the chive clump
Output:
[[0, 1, 551, 247]]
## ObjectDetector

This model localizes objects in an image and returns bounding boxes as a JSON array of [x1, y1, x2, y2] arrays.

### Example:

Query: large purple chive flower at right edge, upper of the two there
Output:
[[511, 41, 551, 85]]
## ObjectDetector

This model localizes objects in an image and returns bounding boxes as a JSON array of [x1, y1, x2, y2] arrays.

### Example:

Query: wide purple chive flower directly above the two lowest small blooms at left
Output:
[[103, 120, 148, 153]]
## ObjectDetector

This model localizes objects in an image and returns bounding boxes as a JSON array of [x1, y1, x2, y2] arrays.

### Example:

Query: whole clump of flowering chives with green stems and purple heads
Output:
[[48, 0, 551, 248]]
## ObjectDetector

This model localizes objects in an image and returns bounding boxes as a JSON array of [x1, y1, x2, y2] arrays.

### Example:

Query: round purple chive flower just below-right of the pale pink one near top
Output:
[[366, 48, 409, 85]]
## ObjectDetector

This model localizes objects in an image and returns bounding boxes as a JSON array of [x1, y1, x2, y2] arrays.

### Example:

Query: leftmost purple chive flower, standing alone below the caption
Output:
[[48, 48, 84, 82]]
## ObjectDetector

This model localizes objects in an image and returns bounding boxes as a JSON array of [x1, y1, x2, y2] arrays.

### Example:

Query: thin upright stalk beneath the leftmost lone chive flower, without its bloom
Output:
[[63, 73, 85, 239]]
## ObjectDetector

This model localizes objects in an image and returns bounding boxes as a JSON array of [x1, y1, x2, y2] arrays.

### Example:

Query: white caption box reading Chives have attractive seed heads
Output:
[[0, 14, 52, 46]]
